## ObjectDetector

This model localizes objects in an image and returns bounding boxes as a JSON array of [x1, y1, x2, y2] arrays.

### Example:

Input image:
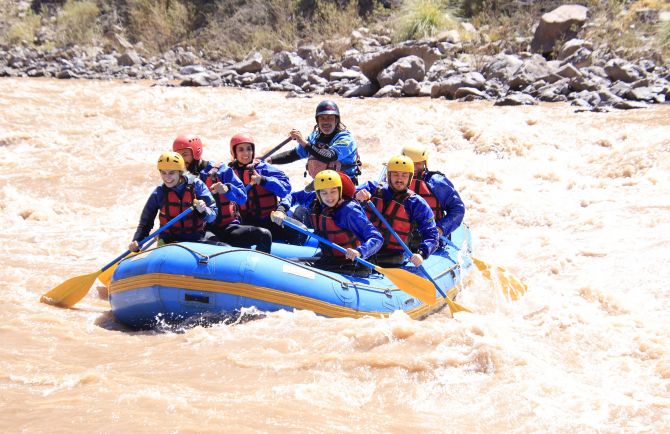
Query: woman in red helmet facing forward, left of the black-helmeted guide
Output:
[[228, 133, 299, 242]]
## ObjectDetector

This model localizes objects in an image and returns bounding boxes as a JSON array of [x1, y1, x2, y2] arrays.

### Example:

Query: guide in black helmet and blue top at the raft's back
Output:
[[266, 100, 361, 185]]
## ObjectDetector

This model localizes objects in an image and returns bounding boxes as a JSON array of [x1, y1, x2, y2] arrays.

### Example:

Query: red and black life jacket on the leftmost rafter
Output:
[[158, 183, 205, 240]]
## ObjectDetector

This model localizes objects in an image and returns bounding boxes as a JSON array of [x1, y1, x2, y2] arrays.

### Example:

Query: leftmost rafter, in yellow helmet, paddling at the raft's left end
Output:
[[128, 151, 217, 252]]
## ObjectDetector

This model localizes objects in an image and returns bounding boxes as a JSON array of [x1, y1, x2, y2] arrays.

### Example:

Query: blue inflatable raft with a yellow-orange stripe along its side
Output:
[[109, 225, 471, 328]]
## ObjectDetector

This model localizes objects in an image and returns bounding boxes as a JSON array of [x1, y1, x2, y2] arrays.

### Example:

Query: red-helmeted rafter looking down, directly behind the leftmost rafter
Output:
[[172, 134, 272, 253]]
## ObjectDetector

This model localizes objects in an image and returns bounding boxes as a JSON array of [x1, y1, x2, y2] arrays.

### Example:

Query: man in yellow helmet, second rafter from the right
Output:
[[356, 155, 438, 267]]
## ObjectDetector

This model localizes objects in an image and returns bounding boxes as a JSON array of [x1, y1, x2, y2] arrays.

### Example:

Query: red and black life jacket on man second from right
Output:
[[365, 188, 416, 250]]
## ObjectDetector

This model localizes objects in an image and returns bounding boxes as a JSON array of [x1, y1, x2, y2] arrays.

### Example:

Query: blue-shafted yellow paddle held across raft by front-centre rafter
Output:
[[283, 220, 436, 304]]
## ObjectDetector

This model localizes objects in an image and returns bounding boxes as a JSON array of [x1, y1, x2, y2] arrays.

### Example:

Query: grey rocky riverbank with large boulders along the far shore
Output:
[[0, 5, 670, 110]]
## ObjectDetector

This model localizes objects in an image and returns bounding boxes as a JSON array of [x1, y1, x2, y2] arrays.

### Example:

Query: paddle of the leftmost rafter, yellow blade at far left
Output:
[[40, 206, 193, 307]]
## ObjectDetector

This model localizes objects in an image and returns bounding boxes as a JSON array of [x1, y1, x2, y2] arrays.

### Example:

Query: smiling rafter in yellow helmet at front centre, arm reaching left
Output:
[[271, 170, 383, 274]]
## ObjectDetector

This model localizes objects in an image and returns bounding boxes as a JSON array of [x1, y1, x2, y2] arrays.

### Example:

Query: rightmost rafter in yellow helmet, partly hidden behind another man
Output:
[[402, 144, 465, 237]]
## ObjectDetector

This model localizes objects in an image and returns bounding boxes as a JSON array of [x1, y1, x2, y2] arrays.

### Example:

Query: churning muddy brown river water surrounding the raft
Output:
[[0, 79, 670, 433]]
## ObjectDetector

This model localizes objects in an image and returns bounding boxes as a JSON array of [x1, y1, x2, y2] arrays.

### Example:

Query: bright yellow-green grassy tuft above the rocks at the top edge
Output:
[[395, 0, 458, 41]]
